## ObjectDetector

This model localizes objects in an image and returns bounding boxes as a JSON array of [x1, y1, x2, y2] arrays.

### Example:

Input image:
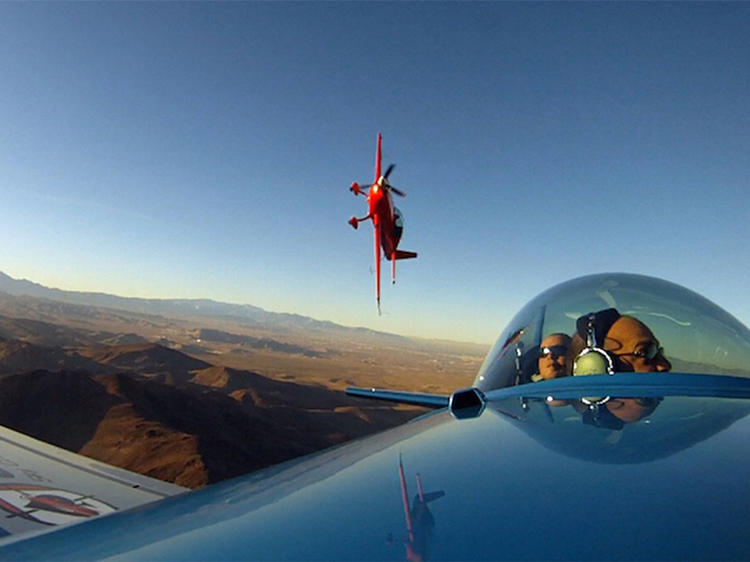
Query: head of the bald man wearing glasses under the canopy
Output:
[[604, 316, 672, 373]]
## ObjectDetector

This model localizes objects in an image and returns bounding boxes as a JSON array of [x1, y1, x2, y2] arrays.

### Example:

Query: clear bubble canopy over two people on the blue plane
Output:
[[474, 273, 750, 391]]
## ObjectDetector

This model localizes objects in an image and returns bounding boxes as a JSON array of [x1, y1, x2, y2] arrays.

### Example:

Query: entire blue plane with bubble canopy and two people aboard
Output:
[[0, 274, 750, 560]]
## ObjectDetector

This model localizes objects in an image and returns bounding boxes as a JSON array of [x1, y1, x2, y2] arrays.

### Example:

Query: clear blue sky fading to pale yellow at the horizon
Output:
[[0, 3, 750, 343]]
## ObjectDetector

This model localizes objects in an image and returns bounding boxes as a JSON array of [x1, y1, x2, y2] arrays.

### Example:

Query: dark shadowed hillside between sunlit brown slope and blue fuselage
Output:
[[107, 373, 418, 482]]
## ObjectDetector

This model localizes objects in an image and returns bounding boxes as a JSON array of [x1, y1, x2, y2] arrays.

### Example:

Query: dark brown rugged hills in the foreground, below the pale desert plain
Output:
[[0, 341, 424, 487]]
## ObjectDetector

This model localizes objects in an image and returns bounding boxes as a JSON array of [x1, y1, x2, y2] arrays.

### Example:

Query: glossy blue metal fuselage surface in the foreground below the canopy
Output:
[[0, 374, 750, 560]]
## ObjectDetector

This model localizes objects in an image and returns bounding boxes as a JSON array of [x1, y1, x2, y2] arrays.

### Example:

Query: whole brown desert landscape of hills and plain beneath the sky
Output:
[[0, 273, 486, 487]]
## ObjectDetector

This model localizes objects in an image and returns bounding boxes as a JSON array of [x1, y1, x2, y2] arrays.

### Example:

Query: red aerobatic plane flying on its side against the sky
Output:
[[349, 133, 417, 311]]
